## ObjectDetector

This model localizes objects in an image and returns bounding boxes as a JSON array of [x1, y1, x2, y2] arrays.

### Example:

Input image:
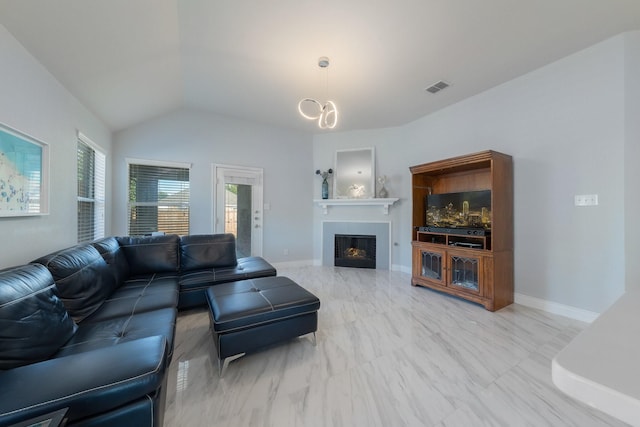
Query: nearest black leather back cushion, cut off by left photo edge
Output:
[[0, 264, 76, 369]]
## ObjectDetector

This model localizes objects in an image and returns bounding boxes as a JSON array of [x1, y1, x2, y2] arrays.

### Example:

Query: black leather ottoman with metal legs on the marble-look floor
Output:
[[206, 276, 320, 376]]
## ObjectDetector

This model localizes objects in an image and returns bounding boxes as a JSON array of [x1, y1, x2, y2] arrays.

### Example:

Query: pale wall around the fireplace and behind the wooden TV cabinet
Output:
[[314, 32, 640, 312]]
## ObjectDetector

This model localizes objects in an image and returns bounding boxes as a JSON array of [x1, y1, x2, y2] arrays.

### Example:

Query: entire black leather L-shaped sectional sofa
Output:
[[0, 234, 276, 427]]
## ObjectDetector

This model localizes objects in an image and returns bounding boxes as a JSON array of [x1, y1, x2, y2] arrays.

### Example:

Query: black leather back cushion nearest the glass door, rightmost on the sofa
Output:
[[180, 233, 237, 271]]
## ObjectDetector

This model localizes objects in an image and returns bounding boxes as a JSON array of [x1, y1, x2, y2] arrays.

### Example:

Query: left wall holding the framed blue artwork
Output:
[[0, 25, 111, 268]]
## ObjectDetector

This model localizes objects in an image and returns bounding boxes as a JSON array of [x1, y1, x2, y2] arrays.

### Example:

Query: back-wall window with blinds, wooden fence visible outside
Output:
[[127, 160, 190, 236]]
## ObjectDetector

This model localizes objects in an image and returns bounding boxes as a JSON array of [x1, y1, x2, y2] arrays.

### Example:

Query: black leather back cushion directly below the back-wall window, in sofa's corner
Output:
[[117, 234, 180, 276]]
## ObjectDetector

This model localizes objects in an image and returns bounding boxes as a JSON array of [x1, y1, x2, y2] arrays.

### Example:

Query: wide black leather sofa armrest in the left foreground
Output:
[[0, 336, 167, 426]]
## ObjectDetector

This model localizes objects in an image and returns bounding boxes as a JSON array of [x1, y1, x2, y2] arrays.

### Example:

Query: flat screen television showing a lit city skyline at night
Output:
[[425, 190, 491, 230]]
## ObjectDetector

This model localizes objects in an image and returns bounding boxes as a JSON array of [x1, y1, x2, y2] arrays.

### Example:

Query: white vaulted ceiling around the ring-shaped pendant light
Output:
[[0, 0, 640, 132]]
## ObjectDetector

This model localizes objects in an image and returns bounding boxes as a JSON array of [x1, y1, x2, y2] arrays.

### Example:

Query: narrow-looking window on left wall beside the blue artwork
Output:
[[78, 132, 107, 243]]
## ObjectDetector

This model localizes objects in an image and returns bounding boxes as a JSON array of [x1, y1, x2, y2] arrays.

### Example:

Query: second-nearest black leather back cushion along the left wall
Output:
[[35, 244, 118, 322]]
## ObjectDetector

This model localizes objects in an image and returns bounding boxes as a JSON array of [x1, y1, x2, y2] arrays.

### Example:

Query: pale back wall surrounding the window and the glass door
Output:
[[112, 111, 314, 262]]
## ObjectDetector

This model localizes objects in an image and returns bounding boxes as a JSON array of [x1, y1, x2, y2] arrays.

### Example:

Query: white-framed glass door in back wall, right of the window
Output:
[[213, 165, 263, 257]]
